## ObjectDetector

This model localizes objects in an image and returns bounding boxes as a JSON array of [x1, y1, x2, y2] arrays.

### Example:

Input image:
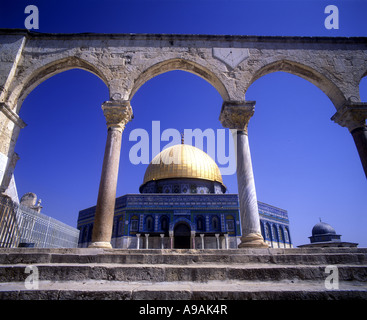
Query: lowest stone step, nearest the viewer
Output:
[[0, 280, 367, 300]]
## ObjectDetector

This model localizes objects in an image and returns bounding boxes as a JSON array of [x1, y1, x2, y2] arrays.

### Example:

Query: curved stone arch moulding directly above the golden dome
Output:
[[129, 58, 229, 101]]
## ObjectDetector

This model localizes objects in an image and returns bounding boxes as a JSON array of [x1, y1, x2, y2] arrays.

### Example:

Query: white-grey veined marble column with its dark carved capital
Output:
[[219, 101, 269, 248]]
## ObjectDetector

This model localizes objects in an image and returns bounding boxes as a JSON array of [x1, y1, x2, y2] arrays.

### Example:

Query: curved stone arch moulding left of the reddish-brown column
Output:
[[9, 56, 108, 113]]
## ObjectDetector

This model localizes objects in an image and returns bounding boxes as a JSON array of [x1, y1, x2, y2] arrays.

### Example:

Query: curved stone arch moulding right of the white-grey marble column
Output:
[[248, 59, 346, 110]]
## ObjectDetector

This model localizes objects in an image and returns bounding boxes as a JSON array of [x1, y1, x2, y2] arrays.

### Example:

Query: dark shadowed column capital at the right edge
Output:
[[331, 102, 367, 132]]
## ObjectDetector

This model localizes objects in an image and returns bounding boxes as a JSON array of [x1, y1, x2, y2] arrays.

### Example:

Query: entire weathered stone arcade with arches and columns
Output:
[[0, 29, 367, 248]]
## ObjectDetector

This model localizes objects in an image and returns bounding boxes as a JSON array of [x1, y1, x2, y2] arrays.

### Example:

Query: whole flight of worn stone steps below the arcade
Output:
[[0, 248, 367, 300]]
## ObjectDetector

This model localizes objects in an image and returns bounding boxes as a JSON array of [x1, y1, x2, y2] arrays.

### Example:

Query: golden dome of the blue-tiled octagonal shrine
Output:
[[143, 144, 223, 185]]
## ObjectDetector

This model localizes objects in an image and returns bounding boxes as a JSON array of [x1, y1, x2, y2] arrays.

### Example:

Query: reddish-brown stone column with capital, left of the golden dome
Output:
[[89, 101, 132, 248]]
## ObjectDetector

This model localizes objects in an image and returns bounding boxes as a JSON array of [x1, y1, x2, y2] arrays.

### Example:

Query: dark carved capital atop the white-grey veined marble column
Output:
[[219, 101, 256, 132]]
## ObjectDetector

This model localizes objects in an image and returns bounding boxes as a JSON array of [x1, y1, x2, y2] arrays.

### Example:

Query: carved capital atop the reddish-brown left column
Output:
[[102, 100, 133, 131]]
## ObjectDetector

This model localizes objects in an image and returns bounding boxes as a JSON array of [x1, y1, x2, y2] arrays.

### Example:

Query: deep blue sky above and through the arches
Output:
[[0, 0, 367, 247]]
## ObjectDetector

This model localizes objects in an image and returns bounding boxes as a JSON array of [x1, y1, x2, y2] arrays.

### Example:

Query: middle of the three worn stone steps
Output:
[[0, 263, 367, 282]]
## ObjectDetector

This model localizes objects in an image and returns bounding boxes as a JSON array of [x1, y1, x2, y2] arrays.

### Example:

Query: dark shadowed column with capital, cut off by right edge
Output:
[[331, 102, 367, 178]]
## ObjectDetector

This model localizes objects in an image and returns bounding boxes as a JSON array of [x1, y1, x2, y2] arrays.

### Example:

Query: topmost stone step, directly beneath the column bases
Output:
[[0, 249, 367, 265]]
